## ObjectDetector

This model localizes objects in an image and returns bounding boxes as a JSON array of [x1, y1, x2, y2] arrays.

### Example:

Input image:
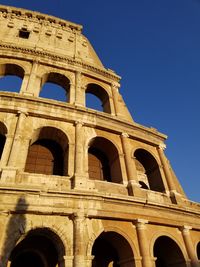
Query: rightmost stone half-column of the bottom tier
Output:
[[181, 226, 199, 267]]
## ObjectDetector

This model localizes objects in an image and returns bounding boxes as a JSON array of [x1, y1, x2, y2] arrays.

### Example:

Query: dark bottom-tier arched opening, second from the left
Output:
[[92, 231, 135, 267]]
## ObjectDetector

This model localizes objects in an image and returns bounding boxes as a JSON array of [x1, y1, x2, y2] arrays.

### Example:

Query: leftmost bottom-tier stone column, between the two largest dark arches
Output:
[[73, 212, 87, 267]]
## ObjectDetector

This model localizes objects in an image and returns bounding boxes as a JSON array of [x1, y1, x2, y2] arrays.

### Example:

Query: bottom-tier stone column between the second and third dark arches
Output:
[[136, 219, 153, 267]]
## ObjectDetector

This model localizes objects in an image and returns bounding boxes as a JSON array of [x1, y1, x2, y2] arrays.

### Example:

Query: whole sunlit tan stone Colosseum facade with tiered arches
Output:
[[0, 6, 200, 267]]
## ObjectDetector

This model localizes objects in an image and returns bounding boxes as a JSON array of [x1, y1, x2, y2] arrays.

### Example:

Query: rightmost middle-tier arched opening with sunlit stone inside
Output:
[[134, 149, 165, 192]]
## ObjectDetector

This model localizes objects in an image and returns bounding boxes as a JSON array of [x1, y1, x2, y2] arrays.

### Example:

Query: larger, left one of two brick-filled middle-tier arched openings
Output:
[[25, 127, 68, 175]]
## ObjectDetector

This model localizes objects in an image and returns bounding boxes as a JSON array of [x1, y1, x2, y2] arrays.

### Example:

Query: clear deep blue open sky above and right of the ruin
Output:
[[0, 0, 200, 202]]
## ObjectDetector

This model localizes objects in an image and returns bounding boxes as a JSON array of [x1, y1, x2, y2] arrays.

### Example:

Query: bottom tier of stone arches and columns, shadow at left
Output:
[[0, 206, 200, 267]]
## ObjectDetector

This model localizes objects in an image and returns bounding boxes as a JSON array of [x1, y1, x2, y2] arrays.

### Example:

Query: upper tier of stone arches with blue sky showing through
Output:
[[0, 61, 120, 114]]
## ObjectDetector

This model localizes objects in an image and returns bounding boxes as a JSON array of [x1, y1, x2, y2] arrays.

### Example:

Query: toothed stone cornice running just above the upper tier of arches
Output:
[[0, 43, 121, 82]]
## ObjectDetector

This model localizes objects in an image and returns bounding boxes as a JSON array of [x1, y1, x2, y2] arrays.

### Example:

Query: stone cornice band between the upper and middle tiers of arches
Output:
[[0, 92, 167, 145]]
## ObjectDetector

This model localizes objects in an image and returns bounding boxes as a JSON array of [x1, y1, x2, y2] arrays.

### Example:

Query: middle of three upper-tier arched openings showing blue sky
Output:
[[39, 72, 70, 102]]
